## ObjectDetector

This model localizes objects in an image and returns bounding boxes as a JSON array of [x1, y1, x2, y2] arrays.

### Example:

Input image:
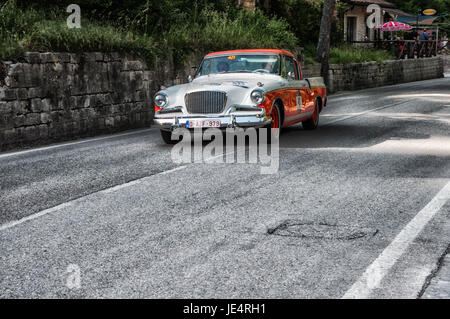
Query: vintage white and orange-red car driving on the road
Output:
[[154, 49, 327, 143]]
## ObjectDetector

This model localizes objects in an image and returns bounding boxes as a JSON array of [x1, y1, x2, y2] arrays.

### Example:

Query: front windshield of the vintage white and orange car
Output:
[[197, 54, 280, 76]]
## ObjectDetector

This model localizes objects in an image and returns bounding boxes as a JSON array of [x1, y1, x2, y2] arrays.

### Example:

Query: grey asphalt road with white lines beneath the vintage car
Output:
[[0, 78, 450, 298]]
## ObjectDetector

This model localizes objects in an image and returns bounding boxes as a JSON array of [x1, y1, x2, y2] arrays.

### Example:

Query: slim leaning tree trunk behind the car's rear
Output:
[[317, 0, 336, 85]]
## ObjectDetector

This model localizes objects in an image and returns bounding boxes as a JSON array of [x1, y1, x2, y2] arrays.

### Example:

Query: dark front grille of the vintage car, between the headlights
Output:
[[184, 91, 227, 114]]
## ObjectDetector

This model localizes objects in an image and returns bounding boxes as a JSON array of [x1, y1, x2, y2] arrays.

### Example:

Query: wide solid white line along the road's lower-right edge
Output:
[[342, 182, 450, 299]]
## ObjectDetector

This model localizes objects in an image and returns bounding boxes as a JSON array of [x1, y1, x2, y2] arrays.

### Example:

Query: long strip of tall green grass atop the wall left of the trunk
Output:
[[0, 0, 297, 63]]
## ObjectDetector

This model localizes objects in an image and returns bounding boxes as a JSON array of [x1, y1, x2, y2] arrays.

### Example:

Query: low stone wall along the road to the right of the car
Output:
[[303, 57, 444, 93]]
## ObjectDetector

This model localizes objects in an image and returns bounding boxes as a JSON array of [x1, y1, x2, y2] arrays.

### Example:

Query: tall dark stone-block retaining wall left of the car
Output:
[[0, 53, 155, 150]]
